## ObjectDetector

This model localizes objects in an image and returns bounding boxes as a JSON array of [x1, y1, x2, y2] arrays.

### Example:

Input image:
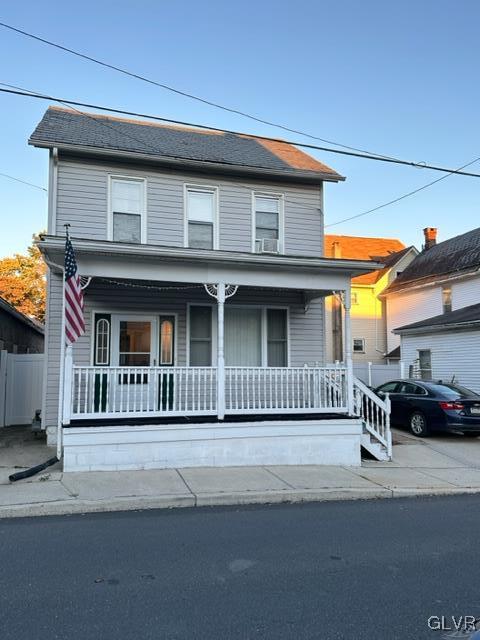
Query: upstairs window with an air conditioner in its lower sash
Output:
[[253, 193, 283, 253]]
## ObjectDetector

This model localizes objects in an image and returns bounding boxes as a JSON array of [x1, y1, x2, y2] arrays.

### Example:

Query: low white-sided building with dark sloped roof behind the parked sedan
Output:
[[395, 303, 480, 393]]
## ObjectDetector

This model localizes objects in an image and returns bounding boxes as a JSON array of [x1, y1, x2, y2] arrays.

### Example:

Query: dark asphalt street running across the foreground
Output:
[[0, 495, 480, 640]]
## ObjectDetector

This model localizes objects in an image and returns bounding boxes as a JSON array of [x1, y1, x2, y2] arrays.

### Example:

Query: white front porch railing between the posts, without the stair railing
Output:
[[63, 366, 348, 424]]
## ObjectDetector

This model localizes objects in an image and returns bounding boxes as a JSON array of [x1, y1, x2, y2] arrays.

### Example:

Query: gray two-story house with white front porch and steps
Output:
[[29, 108, 391, 471]]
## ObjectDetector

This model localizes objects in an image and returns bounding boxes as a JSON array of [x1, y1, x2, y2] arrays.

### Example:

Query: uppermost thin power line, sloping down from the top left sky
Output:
[[0, 22, 398, 158]]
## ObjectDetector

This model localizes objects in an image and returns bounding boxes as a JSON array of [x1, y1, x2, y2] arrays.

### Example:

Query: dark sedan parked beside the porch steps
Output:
[[375, 380, 480, 437]]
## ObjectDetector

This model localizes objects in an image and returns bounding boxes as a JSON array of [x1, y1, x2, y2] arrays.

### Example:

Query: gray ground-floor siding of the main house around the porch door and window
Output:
[[44, 275, 324, 427]]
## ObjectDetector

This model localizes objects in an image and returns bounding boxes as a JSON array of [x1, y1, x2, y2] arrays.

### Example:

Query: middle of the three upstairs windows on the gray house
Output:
[[185, 186, 218, 249]]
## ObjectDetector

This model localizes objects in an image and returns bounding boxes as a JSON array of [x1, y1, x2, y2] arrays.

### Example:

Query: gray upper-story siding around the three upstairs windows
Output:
[[52, 158, 323, 256]]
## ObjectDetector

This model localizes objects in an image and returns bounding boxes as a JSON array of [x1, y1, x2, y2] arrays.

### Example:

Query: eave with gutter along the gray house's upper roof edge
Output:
[[28, 137, 345, 184]]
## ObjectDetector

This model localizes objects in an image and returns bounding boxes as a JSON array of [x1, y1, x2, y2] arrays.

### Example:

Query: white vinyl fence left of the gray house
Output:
[[0, 351, 44, 427]]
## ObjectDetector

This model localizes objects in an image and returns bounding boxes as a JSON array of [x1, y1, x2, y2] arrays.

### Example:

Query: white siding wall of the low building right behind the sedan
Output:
[[402, 331, 480, 393]]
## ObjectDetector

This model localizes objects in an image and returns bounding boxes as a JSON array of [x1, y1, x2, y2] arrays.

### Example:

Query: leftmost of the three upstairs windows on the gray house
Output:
[[109, 177, 146, 243]]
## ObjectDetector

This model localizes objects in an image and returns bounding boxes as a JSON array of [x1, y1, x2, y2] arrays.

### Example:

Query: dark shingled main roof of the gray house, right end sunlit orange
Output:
[[29, 107, 344, 181]]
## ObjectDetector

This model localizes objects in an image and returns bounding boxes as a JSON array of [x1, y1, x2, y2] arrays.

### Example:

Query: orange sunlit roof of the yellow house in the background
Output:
[[324, 234, 411, 284]]
